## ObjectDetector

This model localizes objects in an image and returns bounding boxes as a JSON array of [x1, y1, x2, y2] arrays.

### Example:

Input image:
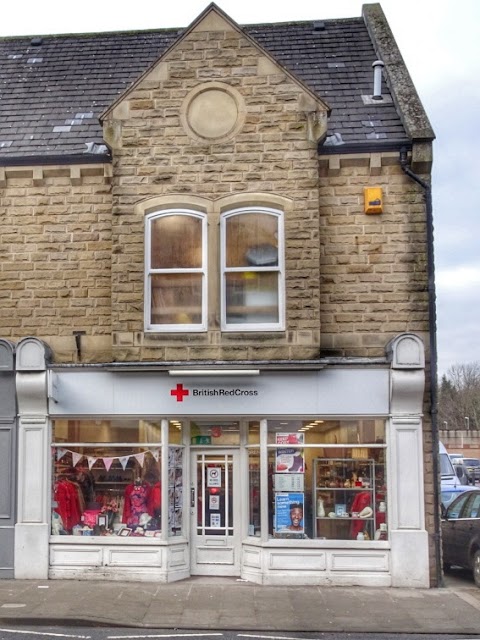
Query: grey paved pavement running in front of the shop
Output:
[[0, 578, 480, 637]]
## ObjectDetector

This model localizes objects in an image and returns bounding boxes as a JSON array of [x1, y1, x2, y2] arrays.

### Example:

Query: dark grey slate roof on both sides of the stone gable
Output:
[[0, 18, 407, 164]]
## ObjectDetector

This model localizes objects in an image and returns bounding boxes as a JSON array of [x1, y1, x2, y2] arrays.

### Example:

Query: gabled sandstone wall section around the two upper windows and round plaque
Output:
[[105, 22, 320, 360]]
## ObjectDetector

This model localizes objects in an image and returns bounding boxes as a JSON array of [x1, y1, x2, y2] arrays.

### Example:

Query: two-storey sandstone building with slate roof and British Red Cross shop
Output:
[[0, 4, 438, 587]]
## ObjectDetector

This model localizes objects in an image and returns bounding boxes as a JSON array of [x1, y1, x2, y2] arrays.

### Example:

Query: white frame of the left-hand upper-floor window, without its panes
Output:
[[144, 208, 208, 333]]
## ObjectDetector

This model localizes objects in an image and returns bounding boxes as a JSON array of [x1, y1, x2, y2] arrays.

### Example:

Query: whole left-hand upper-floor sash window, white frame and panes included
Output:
[[145, 209, 207, 331]]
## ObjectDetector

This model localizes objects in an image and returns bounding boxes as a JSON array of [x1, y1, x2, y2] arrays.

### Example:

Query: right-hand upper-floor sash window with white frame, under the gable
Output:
[[221, 207, 285, 331]]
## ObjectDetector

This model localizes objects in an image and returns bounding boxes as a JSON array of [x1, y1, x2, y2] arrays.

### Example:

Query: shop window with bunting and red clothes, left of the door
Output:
[[52, 420, 166, 538]]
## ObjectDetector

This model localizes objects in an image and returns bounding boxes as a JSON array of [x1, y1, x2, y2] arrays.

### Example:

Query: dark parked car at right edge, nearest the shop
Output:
[[442, 489, 480, 587]]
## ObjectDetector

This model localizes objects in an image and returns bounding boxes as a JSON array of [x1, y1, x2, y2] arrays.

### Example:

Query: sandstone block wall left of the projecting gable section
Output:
[[0, 165, 112, 362]]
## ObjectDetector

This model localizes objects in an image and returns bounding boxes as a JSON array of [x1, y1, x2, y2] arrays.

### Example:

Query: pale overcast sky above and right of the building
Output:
[[0, 0, 480, 374]]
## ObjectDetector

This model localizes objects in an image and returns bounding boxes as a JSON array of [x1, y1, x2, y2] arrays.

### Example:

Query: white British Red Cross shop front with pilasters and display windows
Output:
[[15, 334, 429, 587]]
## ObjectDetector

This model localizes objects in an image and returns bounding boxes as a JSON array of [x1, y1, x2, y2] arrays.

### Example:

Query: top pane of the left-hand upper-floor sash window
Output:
[[151, 215, 202, 269]]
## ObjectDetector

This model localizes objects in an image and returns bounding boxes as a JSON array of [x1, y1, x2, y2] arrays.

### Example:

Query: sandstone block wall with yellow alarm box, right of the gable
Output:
[[319, 153, 429, 357]]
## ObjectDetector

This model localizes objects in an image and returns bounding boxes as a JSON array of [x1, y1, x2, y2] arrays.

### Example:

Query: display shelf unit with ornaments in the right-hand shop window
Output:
[[312, 458, 386, 540]]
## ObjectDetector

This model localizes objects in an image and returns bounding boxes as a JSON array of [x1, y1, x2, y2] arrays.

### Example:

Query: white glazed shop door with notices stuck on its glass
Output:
[[190, 448, 240, 576]]
